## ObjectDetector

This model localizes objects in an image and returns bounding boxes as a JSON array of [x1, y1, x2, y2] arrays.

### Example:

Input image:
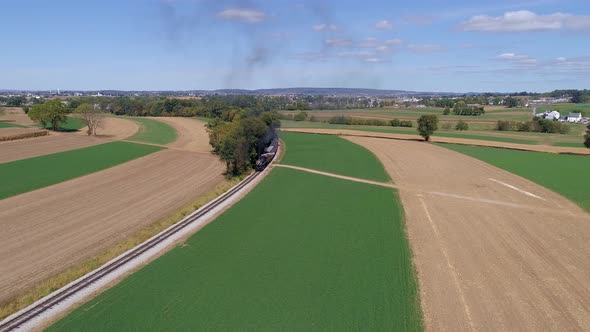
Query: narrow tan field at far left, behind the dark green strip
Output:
[[0, 118, 139, 163]]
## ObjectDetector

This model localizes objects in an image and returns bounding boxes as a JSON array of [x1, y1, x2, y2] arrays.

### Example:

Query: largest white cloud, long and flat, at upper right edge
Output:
[[461, 10, 590, 32]]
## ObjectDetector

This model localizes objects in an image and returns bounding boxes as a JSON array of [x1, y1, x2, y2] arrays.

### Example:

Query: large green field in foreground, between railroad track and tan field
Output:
[[49, 169, 422, 331]]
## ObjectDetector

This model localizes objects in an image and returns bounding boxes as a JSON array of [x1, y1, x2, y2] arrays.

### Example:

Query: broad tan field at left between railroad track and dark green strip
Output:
[[0, 150, 224, 303]]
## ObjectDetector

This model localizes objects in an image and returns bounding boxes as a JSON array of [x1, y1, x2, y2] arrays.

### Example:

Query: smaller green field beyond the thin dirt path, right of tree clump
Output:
[[281, 132, 390, 182]]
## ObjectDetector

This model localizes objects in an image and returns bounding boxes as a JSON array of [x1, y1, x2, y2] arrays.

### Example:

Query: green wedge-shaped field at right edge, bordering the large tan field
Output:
[[441, 144, 590, 211]]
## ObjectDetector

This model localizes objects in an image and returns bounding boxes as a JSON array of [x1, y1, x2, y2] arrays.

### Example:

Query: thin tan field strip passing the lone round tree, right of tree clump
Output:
[[281, 128, 590, 155]]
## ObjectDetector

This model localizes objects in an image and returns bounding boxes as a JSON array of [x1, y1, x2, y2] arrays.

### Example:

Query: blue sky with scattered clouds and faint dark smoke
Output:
[[0, 0, 590, 92]]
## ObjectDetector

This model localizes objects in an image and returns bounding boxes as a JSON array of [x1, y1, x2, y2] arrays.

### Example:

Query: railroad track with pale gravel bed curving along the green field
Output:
[[0, 169, 266, 332]]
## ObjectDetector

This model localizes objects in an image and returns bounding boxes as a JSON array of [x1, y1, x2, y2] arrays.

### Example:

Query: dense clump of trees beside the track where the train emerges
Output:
[[208, 112, 280, 177]]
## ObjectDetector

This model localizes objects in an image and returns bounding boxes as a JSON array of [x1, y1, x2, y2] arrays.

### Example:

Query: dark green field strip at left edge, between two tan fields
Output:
[[0, 142, 161, 199]]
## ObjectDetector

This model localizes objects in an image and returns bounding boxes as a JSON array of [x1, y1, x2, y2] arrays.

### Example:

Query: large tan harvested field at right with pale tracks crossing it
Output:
[[346, 136, 590, 331]]
